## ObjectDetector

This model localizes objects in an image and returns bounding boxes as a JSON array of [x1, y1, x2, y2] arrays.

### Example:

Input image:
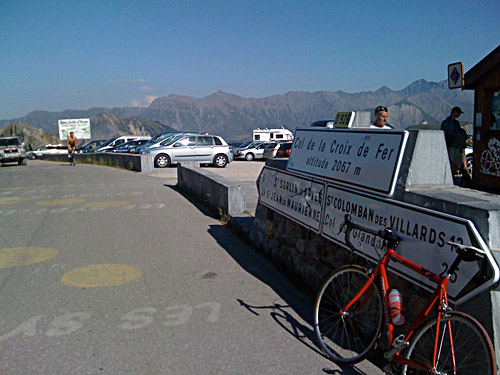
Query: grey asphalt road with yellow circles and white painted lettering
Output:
[[0, 161, 381, 375]]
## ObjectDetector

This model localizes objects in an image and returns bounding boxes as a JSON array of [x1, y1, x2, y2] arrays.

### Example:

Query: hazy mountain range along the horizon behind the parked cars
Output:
[[0, 79, 474, 140]]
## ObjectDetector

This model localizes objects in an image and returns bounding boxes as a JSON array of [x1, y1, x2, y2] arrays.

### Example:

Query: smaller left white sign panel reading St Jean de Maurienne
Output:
[[259, 167, 325, 232]]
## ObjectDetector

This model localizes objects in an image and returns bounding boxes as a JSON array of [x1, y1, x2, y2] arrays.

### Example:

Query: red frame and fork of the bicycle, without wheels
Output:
[[340, 247, 453, 371]]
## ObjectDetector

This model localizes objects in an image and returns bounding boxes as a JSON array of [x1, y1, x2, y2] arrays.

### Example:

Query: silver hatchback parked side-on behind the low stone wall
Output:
[[144, 135, 233, 168]]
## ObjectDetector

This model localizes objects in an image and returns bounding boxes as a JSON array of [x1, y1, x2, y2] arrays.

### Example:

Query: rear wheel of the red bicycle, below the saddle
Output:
[[402, 312, 496, 375]]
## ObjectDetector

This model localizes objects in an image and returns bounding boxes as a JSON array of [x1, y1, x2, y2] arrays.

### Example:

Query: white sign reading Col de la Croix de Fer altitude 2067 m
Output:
[[287, 129, 408, 195]]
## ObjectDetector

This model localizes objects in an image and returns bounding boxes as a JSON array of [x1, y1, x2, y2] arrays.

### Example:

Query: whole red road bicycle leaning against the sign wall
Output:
[[314, 215, 496, 375]]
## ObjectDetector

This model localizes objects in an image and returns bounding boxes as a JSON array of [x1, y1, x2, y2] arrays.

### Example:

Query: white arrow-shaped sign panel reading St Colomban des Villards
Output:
[[321, 186, 498, 303]]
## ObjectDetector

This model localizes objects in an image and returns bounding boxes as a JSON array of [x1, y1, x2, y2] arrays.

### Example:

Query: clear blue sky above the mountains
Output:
[[0, 0, 500, 119]]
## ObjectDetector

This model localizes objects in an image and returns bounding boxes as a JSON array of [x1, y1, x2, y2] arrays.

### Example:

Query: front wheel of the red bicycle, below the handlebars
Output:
[[314, 265, 384, 364]]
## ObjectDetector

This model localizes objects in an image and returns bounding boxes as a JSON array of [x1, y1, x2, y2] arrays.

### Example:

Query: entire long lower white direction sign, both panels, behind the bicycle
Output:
[[259, 166, 499, 303]]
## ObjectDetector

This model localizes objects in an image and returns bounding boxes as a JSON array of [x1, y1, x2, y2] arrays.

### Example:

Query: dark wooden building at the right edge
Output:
[[464, 46, 500, 192]]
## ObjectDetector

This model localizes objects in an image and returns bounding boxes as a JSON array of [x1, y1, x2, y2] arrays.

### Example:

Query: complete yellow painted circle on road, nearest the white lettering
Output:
[[61, 264, 142, 288]]
